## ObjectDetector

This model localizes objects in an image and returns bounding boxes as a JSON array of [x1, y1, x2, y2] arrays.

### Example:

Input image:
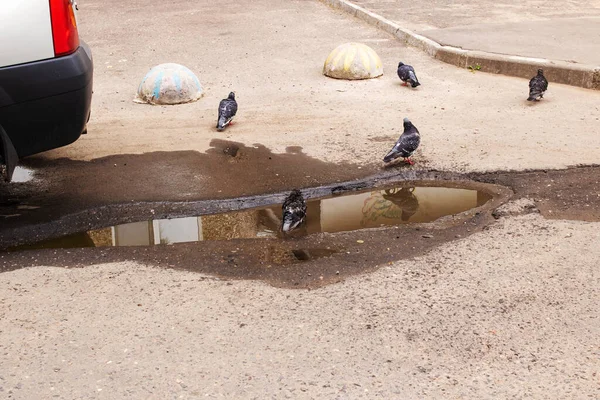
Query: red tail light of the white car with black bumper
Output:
[[50, 0, 79, 57]]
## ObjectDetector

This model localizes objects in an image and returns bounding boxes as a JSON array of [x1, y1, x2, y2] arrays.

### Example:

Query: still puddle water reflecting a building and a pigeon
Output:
[[12, 187, 491, 248]]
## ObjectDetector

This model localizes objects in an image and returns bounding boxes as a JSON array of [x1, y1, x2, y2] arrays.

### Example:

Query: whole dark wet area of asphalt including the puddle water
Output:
[[0, 141, 600, 288]]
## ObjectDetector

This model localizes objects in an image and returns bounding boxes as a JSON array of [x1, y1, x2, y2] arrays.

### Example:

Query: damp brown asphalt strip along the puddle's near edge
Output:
[[0, 208, 500, 289]]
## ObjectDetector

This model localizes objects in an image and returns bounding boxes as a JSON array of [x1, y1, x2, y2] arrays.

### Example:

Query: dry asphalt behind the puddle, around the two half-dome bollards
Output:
[[45, 0, 600, 173]]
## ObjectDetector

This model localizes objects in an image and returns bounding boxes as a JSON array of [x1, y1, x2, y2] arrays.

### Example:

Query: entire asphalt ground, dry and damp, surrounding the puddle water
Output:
[[0, 0, 600, 399]]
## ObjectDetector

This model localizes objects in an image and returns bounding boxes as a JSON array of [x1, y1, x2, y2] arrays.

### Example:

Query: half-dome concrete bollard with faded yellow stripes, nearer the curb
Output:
[[323, 43, 383, 80]]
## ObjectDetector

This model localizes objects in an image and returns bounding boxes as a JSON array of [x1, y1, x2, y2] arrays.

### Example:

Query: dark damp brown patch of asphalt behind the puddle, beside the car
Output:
[[0, 139, 376, 231]]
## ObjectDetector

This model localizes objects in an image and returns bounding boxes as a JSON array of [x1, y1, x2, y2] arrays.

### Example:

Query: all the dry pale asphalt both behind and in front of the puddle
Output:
[[0, 0, 600, 400]]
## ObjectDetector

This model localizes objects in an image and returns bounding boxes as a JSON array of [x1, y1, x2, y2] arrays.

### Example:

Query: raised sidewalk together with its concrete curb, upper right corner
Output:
[[324, 0, 600, 89]]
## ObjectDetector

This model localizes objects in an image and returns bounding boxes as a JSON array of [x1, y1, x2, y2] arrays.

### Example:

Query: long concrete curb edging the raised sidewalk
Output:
[[320, 0, 600, 90]]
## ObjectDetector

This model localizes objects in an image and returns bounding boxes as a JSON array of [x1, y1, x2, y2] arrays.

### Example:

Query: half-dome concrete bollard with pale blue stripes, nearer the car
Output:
[[134, 63, 203, 104]]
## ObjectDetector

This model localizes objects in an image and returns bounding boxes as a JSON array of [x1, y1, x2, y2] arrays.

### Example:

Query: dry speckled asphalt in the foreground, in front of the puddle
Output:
[[0, 214, 600, 400]]
